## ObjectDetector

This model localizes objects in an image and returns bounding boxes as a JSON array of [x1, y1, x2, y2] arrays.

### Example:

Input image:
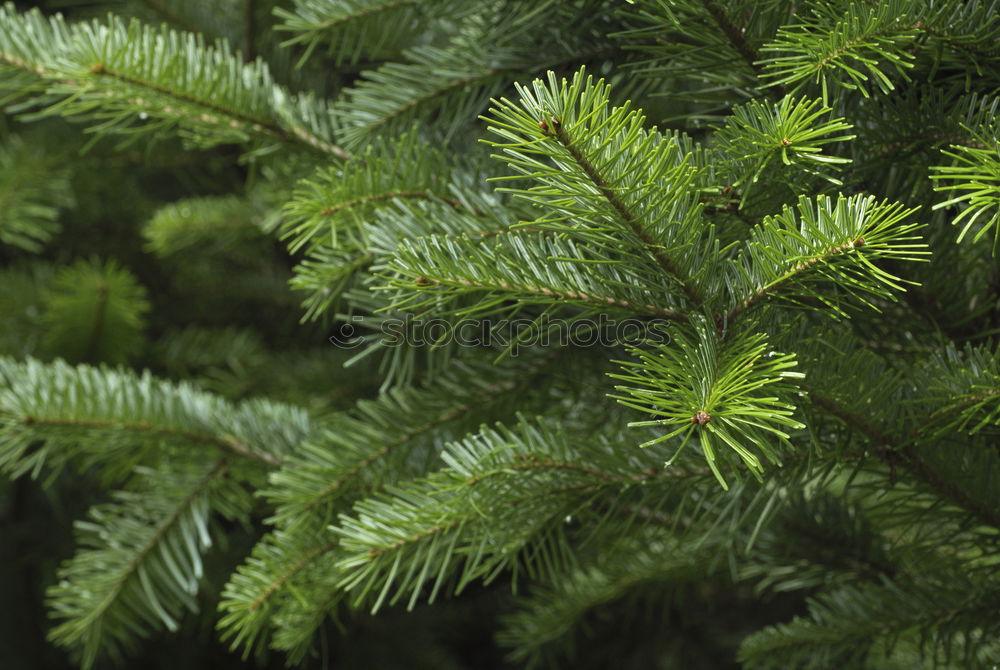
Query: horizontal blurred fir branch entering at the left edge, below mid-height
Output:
[[0, 359, 308, 479]]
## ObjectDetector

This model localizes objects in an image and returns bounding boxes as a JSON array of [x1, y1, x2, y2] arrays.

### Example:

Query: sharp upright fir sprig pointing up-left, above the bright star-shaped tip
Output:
[[489, 70, 714, 310]]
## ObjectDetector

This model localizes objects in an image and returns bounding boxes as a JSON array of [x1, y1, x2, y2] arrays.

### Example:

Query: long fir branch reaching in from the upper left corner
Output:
[[0, 4, 350, 159]]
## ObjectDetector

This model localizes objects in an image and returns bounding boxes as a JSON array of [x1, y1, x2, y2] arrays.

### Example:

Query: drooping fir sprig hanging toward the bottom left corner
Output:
[[49, 460, 252, 668]]
